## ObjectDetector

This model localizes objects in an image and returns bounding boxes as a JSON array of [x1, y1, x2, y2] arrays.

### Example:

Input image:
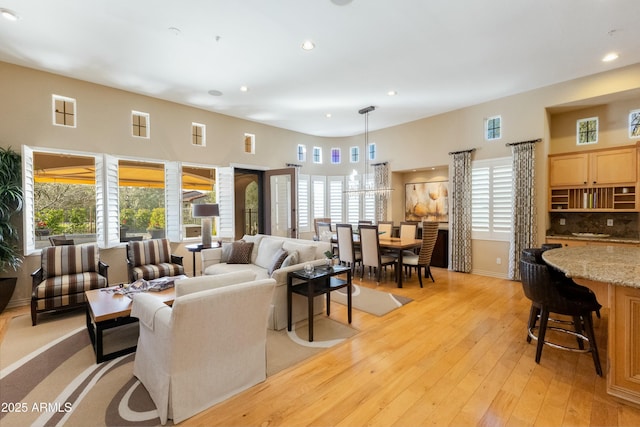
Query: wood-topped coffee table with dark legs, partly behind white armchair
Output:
[[85, 285, 175, 363]]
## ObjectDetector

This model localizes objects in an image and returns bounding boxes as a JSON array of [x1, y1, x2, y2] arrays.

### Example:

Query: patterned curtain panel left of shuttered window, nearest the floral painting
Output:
[[449, 151, 471, 273]]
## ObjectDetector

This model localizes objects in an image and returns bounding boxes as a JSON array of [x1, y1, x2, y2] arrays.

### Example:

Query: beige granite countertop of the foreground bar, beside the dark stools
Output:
[[542, 246, 640, 288]]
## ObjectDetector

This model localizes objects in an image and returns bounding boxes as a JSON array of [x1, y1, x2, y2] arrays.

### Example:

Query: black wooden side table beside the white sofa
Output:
[[287, 265, 352, 342]]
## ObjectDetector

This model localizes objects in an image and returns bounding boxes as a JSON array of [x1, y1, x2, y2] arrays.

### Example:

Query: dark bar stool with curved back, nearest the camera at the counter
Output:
[[520, 256, 602, 376]]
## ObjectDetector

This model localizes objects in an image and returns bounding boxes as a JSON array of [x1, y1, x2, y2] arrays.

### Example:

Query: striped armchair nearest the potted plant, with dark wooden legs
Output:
[[31, 244, 109, 326]]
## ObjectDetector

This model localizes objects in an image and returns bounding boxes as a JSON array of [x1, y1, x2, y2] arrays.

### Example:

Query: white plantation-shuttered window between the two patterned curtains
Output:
[[471, 157, 513, 241]]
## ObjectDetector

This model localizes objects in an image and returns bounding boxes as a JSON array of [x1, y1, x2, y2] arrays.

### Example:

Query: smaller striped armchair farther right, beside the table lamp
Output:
[[127, 239, 184, 283]]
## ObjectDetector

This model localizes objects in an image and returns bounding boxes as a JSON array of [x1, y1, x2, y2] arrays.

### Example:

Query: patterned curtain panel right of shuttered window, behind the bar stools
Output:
[[509, 141, 537, 280]]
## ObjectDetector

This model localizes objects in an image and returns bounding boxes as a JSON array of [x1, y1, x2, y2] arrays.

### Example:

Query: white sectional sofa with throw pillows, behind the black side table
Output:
[[200, 234, 331, 330]]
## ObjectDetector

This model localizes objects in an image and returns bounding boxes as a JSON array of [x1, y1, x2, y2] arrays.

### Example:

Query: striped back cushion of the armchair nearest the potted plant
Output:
[[41, 244, 99, 279]]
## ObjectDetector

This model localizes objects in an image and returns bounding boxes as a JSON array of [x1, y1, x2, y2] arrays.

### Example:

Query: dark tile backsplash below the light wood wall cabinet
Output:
[[547, 212, 640, 239]]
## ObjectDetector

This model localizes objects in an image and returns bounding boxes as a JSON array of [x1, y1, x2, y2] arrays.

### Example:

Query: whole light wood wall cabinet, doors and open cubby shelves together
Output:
[[549, 145, 640, 212]]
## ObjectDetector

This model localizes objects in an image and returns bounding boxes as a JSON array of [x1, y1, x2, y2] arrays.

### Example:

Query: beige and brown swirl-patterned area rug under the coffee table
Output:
[[0, 314, 358, 427]]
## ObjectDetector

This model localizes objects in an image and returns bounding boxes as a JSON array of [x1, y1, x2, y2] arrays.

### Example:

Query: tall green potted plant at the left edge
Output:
[[0, 147, 24, 312]]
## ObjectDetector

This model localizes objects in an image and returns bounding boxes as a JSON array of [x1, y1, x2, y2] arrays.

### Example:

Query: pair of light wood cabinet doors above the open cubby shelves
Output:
[[549, 146, 638, 187]]
